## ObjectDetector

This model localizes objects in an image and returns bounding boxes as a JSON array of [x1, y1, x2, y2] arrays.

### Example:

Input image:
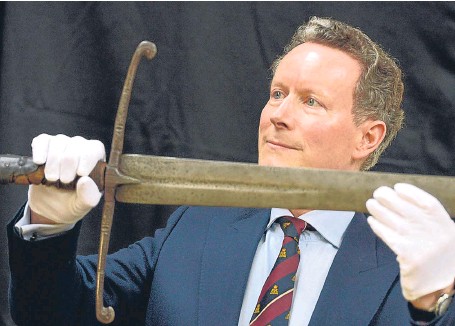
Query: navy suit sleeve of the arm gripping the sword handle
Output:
[[7, 207, 191, 325]]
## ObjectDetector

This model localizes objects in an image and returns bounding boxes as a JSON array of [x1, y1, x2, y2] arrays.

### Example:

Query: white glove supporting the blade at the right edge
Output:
[[366, 183, 455, 301]]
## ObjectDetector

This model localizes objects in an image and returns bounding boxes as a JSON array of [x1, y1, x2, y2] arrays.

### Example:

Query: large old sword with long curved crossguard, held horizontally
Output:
[[0, 41, 455, 323]]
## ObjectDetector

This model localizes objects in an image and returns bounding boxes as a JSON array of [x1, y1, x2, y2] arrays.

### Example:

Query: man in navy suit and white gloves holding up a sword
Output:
[[8, 18, 455, 325]]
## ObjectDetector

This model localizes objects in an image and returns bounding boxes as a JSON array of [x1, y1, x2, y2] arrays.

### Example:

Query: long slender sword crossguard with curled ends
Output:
[[96, 41, 157, 324]]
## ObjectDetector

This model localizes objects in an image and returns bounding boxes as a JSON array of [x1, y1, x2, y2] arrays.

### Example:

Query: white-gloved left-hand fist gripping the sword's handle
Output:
[[28, 134, 106, 224]]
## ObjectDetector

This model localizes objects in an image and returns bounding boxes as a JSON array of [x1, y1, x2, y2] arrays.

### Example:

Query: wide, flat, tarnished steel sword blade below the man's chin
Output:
[[116, 154, 455, 216]]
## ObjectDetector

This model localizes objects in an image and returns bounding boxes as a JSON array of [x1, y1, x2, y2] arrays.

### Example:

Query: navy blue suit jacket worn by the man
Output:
[[8, 207, 455, 326]]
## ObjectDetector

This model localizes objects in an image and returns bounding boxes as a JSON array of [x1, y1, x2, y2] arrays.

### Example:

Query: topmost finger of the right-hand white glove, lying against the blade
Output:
[[394, 183, 449, 216]]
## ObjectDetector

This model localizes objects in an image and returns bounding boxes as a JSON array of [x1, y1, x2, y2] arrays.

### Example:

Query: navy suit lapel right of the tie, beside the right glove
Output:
[[310, 213, 399, 325]]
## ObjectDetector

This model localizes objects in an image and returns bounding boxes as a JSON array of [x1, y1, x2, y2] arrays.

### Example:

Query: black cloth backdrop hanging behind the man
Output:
[[0, 2, 455, 325]]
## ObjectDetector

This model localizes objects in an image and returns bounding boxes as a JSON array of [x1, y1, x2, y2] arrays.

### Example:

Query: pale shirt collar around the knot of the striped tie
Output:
[[267, 208, 355, 248]]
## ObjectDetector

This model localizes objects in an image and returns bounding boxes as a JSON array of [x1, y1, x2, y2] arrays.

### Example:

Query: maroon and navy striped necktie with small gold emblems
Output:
[[250, 216, 307, 326]]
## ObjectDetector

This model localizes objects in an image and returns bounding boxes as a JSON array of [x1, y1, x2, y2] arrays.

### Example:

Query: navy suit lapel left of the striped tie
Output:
[[198, 209, 270, 325]]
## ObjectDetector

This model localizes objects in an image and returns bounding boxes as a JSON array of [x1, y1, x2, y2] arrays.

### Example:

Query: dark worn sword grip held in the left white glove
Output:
[[0, 155, 106, 191]]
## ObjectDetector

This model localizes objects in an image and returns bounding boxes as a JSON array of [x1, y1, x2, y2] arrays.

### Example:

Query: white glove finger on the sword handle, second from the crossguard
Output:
[[60, 136, 87, 183]]
